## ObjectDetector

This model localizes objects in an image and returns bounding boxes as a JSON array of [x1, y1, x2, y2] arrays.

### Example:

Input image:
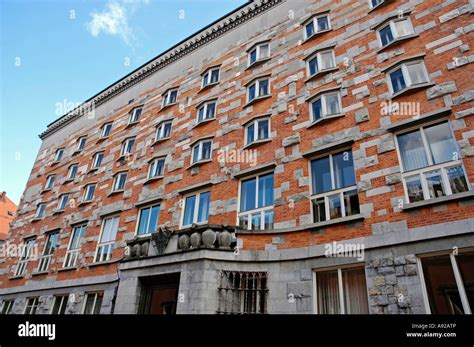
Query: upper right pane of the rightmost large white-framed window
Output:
[[424, 123, 461, 164]]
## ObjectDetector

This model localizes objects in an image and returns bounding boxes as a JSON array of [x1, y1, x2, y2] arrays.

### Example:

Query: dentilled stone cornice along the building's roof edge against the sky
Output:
[[39, 0, 285, 140]]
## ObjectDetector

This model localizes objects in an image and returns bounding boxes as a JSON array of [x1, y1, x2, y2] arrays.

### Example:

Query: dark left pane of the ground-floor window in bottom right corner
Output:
[[421, 255, 464, 314]]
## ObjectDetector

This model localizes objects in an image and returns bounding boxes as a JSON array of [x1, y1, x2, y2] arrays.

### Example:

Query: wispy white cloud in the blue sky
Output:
[[86, 0, 145, 46]]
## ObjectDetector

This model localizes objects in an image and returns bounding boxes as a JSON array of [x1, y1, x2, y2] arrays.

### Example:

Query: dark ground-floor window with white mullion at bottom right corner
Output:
[[421, 252, 474, 314]]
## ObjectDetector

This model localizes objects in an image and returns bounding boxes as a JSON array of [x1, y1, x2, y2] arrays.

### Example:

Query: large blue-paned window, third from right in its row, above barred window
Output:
[[238, 173, 274, 230]]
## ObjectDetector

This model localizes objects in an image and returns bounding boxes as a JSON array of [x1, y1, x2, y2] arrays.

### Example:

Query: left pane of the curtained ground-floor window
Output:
[[316, 271, 341, 314]]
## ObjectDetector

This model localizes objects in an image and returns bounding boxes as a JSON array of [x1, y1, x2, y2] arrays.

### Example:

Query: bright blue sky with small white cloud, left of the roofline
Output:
[[0, 0, 247, 204]]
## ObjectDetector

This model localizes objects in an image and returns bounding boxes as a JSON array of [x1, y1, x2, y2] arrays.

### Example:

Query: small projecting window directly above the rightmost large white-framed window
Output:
[[388, 60, 429, 94]]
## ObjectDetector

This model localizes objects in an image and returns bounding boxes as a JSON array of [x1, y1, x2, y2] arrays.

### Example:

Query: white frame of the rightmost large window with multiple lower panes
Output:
[[395, 122, 472, 204]]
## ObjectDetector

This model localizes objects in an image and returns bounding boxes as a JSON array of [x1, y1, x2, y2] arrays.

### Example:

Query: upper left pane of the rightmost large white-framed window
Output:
[[397, 130, 428, 171]]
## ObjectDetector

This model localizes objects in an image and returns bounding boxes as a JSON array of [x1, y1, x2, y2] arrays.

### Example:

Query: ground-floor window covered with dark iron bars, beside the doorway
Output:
[[217, 270, 268, 314]]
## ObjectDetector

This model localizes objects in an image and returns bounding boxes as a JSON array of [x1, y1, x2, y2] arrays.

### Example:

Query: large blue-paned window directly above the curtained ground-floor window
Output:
[[311, 150, 360, 223]]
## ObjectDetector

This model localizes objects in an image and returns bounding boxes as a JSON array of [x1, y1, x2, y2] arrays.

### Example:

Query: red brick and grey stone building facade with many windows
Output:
[[0, 0, 474, 314]]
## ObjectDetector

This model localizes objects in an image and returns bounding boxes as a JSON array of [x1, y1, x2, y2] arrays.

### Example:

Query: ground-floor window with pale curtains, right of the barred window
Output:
[[315, 267, 369, 314]]
